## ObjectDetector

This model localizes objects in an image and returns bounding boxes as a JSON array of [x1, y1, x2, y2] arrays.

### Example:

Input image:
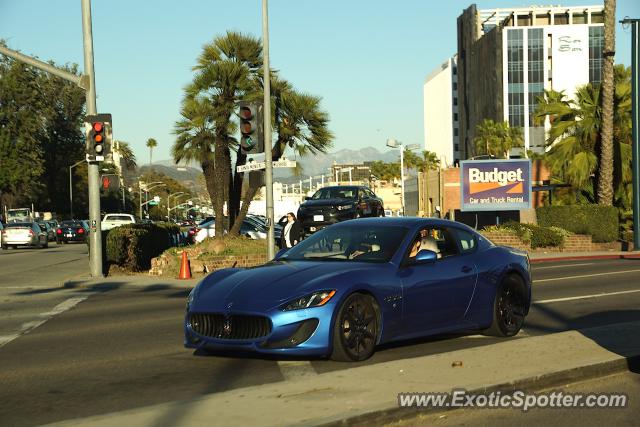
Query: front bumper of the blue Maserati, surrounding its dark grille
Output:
[[184, 304, 334, 356]]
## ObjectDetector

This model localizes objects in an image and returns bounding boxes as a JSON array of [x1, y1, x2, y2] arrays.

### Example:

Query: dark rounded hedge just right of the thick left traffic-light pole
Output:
[[106, 223, 180, 271]]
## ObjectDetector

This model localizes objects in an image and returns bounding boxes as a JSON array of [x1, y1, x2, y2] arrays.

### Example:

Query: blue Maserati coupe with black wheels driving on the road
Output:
[[184, 218, 531, 361]]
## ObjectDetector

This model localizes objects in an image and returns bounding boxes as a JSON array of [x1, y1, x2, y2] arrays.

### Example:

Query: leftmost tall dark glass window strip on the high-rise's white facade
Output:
[[507, 29, 525, 127]]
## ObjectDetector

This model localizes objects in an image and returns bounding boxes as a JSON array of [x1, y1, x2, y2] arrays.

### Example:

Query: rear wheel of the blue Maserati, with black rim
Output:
[[483, 274, 526, 337]]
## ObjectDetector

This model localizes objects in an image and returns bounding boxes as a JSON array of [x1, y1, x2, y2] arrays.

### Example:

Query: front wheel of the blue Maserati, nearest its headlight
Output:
[[331, 293, 379, 362]]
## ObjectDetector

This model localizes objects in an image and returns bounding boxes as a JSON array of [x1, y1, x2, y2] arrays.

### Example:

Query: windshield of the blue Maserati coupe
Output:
[[280, 224, 407, 262]]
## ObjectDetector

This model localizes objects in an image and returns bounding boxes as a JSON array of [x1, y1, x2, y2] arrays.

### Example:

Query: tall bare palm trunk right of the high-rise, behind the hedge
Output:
[[598, 0, 616, 206]]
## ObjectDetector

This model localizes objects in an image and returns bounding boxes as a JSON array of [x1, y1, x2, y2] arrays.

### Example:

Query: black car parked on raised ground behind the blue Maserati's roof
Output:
[[298, 186, 384, 234]]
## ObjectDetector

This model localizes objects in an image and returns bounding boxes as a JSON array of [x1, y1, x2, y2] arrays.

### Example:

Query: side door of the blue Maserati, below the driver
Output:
[[400, 227, 477, 333]]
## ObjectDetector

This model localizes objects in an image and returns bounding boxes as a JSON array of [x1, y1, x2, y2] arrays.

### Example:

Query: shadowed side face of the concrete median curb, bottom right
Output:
[[324, 354, 640, 427]]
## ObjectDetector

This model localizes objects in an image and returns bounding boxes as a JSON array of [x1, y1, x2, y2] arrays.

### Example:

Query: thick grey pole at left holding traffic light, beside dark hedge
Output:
[[81, 0, 103, 277]]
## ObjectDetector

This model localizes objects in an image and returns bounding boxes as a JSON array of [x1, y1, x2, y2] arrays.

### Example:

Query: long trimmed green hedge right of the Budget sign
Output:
[[536, 205, 618, 242]]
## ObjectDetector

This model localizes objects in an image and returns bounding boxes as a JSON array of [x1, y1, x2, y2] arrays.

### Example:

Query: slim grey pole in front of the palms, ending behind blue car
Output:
[[262, 0, 276, 261]]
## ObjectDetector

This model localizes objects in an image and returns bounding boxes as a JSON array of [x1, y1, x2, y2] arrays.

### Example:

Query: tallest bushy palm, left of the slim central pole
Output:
[[173, 32, 262, 236]]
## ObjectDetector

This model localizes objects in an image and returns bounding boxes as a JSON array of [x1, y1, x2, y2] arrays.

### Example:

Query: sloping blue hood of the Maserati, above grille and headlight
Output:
[[192, 261, 380, 312]]
